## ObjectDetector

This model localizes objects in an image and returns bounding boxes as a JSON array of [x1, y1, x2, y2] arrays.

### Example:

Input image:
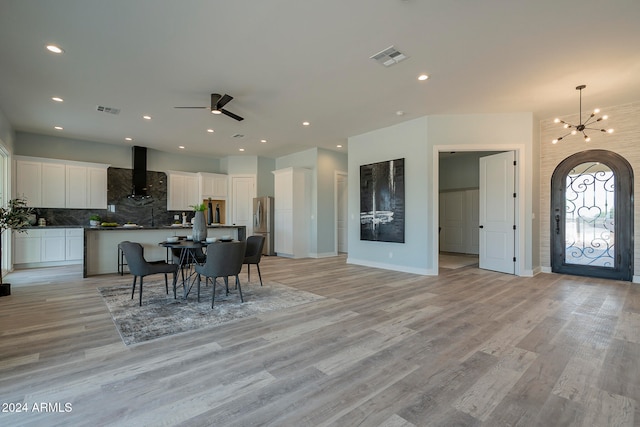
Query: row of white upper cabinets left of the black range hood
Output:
[[15, 156, 109, 209]]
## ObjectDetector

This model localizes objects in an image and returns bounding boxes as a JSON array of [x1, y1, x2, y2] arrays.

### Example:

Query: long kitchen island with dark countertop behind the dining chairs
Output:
[[82, 225, 246, 277]]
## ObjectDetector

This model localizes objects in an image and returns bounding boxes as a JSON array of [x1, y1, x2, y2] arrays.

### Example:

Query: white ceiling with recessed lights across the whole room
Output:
[[0, 0, 640, 157]]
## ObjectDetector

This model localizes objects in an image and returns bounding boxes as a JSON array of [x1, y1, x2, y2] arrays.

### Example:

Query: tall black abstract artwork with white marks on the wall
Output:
[[360, 159, 405, 243]]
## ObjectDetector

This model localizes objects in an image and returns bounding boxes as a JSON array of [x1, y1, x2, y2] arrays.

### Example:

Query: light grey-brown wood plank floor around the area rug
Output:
[[0, 256, 640, 427]]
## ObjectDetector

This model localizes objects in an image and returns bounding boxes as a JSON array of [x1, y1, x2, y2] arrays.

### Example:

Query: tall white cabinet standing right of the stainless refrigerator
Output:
[[273, 168, 311, 258]]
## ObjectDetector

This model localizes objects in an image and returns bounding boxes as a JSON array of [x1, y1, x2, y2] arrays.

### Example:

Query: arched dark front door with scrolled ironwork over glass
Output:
[[551, 150, 633, 281]]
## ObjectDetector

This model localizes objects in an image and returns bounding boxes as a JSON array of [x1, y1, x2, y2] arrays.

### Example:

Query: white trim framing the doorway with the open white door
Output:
[[427, 144, 526, 276]]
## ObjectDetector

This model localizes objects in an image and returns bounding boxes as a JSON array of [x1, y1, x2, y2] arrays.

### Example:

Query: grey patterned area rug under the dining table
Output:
[[98, 278, 324, 345]]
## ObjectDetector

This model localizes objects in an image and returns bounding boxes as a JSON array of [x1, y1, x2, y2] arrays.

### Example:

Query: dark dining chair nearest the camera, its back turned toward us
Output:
[[195, 240, 247, 308]]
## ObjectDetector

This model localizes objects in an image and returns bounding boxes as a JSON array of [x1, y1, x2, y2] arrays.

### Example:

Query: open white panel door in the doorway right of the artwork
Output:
[[479, 151, 516, 274]]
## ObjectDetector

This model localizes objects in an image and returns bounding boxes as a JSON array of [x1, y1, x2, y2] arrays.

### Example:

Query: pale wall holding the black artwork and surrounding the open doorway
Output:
[[348, 113, 537, 275]]
